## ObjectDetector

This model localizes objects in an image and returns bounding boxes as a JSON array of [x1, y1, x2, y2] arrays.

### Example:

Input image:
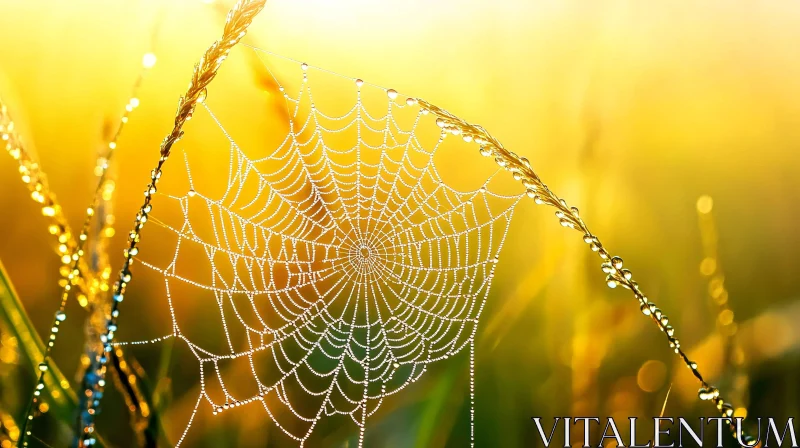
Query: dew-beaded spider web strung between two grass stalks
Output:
[[118, 44, 521, 446]]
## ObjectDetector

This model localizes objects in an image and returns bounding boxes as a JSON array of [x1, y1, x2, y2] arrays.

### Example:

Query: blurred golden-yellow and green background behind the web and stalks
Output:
[[0, 0, 800, 447]]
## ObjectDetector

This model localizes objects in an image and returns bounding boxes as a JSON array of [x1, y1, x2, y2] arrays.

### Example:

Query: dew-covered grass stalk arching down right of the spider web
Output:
[[417, 99, 755, 442]]
